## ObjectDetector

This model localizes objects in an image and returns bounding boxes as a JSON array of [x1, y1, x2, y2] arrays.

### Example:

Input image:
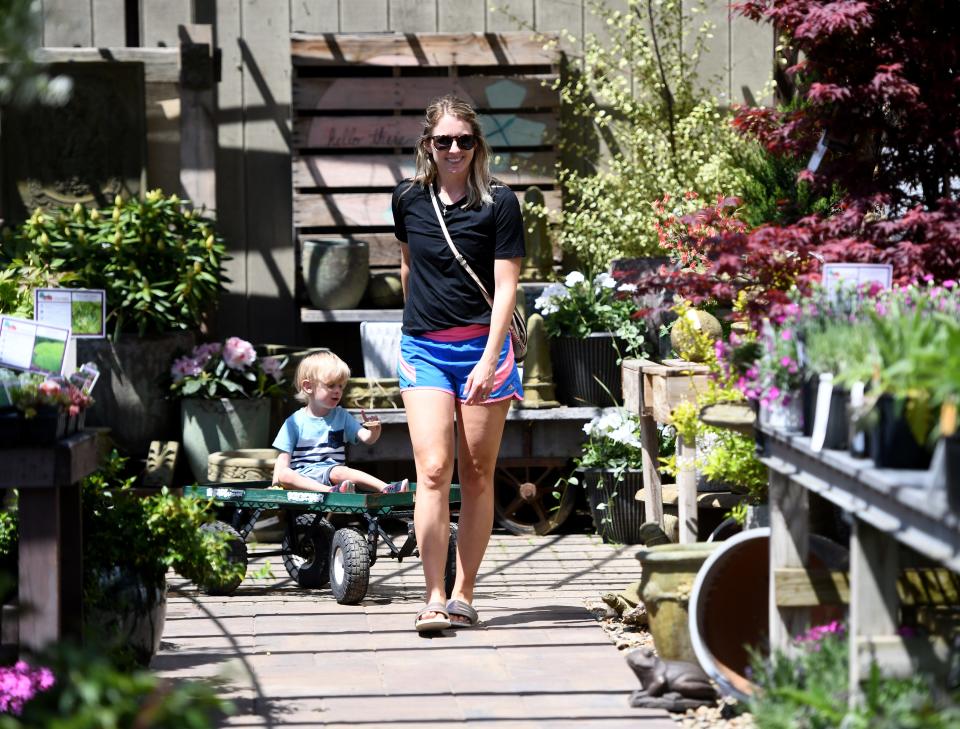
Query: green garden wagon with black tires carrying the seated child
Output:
[[184, 481, 460, 605]]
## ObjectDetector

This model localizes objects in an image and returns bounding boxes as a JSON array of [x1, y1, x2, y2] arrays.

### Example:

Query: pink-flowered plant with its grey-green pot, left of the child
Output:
[[170, 337, 286, 481]]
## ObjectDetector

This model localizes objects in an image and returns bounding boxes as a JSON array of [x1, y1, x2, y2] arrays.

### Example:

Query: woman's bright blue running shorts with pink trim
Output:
[[397, 325, 523, 403]]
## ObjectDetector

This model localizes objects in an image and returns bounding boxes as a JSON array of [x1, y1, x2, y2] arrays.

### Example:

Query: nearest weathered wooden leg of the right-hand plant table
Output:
[[849, 518, 900, 706]]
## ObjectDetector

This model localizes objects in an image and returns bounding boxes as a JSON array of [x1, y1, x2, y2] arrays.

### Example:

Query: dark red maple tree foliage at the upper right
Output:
[[643, 0, 960, 318]]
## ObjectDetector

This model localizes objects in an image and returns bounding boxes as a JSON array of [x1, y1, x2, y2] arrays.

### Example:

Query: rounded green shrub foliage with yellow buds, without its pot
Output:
[[0, 190, 227, 335]]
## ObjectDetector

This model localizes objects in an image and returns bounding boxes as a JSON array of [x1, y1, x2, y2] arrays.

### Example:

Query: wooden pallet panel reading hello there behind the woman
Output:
[[290, 30, 559, 278]]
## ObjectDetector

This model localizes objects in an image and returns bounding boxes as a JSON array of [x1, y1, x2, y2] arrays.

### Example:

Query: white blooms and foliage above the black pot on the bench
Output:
[[533, 271, 646, 356]]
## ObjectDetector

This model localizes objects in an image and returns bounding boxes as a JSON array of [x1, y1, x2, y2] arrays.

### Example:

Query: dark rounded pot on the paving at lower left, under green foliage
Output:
[[84, 567, 167, 667]]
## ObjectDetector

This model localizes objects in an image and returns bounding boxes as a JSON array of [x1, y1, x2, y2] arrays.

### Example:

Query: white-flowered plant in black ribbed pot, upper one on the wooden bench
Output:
[[534, 271, 644, 407]]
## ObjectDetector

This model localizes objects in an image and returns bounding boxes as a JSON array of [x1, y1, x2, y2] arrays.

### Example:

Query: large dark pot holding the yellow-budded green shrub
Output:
[[77, 332, 196, 456]]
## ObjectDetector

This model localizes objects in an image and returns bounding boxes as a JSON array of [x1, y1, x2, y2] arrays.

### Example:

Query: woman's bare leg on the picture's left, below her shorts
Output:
[[402, 390, 454, 617]]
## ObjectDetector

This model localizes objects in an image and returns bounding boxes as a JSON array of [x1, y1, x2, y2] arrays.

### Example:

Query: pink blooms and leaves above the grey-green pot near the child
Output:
[[170, 337, 287, 400]]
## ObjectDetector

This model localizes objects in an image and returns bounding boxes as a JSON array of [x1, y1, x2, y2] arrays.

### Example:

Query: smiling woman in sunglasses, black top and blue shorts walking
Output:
[[393, 96, 524, 632]]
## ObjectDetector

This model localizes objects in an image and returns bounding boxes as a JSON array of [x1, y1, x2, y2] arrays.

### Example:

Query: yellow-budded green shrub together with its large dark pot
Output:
[[0, 190, 227, 454]]
